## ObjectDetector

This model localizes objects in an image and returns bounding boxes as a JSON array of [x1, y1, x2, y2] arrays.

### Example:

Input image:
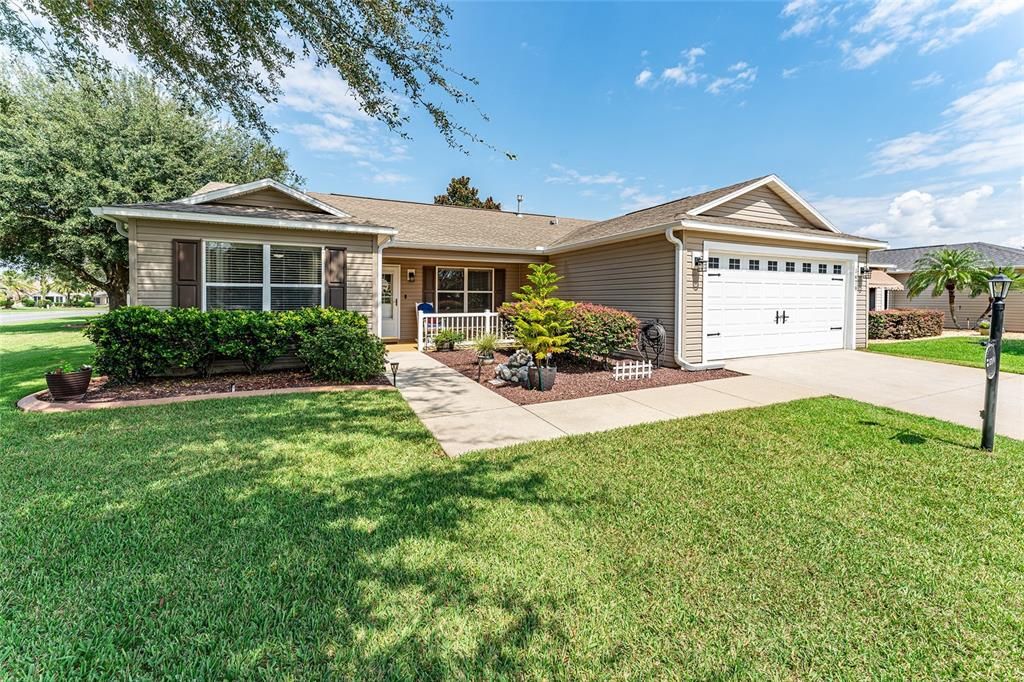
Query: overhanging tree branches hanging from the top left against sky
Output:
[[0, 0, 476, 146]]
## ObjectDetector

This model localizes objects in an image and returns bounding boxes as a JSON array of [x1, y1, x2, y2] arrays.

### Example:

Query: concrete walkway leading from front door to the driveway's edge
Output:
[[389, 352, 824, 457]]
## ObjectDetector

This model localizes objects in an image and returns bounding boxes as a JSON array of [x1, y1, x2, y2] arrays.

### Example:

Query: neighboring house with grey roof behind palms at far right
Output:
[[869, 242, 1024, 332]]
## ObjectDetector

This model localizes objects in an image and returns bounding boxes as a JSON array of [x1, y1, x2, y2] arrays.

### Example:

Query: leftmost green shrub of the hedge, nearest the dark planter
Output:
[[85, 305, 170, 384]]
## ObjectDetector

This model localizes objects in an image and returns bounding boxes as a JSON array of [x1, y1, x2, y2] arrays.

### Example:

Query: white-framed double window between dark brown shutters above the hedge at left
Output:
[[204, 242, 324, 310]]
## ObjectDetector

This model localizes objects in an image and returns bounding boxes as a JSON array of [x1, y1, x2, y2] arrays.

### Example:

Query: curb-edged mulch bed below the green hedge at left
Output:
[[38, 370, 391, 402]]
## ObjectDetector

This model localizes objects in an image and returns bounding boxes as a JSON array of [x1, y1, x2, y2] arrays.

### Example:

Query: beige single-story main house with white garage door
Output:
[[92, 175, 886, 369]]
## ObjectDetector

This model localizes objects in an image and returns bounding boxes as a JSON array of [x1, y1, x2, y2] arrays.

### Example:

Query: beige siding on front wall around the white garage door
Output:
[[683, 230, 867, 364]]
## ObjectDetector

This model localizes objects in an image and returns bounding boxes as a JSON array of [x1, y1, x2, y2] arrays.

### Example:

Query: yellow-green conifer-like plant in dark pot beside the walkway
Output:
[[513, 263, 572, 391]]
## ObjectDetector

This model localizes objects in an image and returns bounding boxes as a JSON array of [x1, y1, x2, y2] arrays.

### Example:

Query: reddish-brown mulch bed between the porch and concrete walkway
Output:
[[427, 349, 742, 404]]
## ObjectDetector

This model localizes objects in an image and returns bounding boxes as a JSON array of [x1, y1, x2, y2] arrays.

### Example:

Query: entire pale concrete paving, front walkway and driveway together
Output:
[[390, 350, 1024, 457]]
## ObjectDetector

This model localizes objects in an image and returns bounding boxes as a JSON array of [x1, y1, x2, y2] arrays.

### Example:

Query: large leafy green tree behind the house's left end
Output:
[[0, 71, 301, 308]]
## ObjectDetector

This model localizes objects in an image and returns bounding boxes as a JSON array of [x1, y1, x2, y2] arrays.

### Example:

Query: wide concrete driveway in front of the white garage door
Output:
[[728, 350, 1024, 439]]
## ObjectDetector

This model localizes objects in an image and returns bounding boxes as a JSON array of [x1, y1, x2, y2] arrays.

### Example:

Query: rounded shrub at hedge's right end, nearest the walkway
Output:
[[296, 324, 387, 383]]
